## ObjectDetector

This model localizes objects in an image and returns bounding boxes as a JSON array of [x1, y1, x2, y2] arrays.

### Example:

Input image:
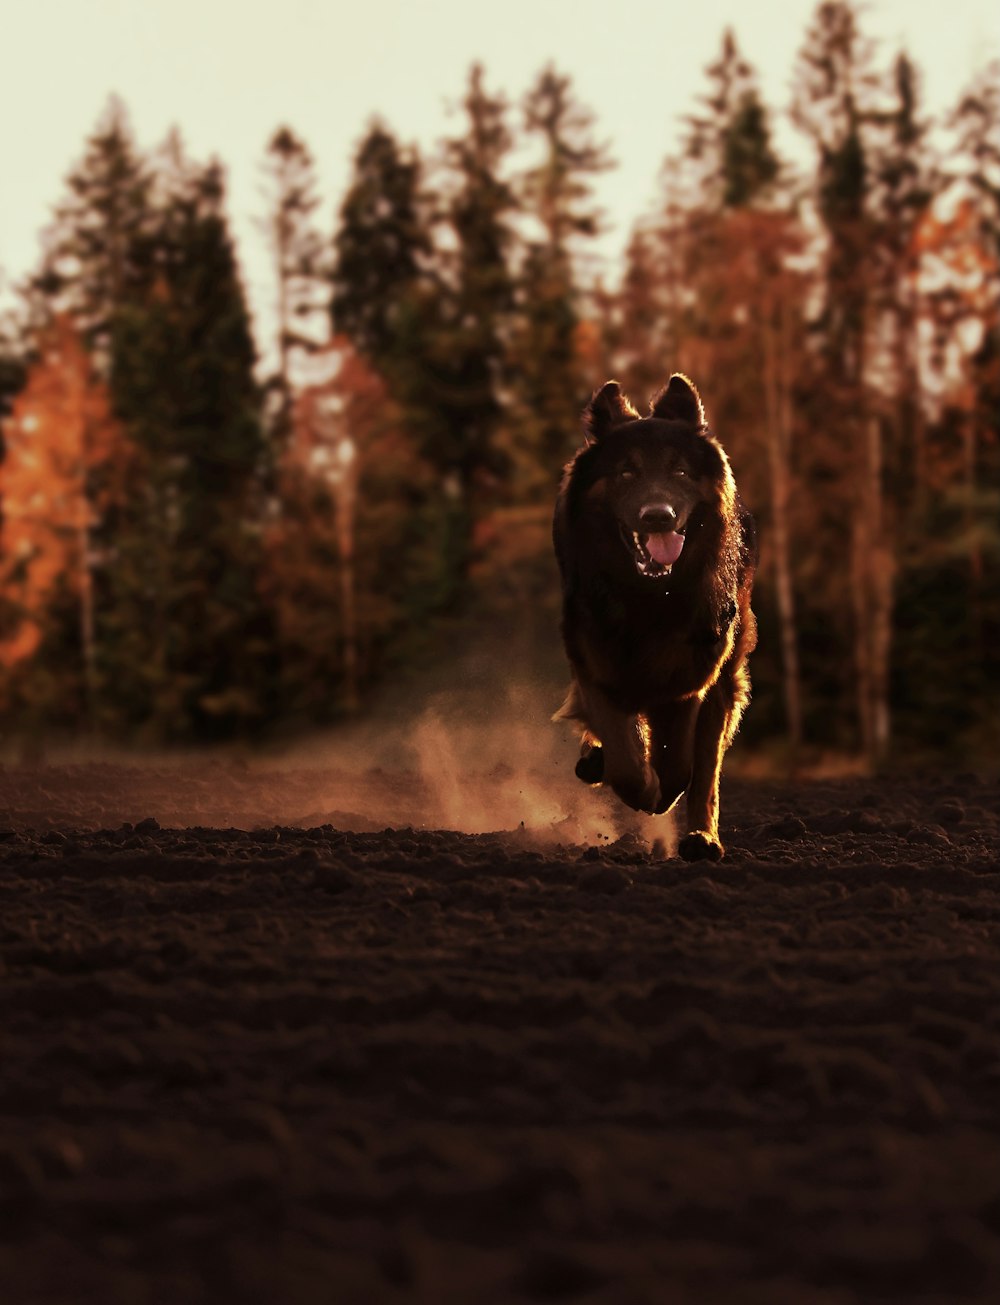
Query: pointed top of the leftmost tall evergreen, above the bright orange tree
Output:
[[31, 97, 150, 376]]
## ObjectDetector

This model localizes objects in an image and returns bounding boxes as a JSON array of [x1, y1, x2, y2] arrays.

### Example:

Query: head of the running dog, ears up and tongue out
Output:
[[584, 372, 735, 578]]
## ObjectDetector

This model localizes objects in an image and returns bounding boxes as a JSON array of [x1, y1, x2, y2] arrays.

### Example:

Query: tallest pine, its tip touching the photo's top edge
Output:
[[792, 0, 893, 762]]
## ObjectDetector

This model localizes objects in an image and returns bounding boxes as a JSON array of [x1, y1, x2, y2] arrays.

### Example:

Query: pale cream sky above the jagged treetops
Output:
[[0, 0, 1000, 349]]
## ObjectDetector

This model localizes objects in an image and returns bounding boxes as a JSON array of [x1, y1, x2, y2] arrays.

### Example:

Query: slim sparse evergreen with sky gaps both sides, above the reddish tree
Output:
[[261, 127, 329, 427]]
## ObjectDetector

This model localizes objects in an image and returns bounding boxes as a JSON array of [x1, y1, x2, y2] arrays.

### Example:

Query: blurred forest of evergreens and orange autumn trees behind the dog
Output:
[[0, 0, 1000, 769]]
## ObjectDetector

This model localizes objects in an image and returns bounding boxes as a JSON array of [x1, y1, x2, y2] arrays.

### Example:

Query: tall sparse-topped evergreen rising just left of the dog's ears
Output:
[[513, 65, 611, 488]]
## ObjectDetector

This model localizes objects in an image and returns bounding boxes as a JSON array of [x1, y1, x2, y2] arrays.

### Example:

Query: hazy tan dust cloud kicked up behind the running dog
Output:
[[0, 664, 676, 855]]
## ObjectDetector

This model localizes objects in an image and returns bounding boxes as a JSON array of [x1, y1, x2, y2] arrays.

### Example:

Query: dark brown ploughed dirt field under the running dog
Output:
[[0, 765, 1000, 1305]]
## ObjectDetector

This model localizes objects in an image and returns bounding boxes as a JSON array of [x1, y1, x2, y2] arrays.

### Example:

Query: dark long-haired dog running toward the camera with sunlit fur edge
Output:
[[552, 372, 757, 861]]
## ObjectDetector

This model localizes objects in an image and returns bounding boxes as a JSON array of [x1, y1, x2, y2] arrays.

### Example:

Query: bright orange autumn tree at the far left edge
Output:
[[0, 316, 120, 715]]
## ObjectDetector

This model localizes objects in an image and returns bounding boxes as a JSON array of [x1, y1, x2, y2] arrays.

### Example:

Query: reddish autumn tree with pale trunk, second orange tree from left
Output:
[[264, 337, 446, 724]]
